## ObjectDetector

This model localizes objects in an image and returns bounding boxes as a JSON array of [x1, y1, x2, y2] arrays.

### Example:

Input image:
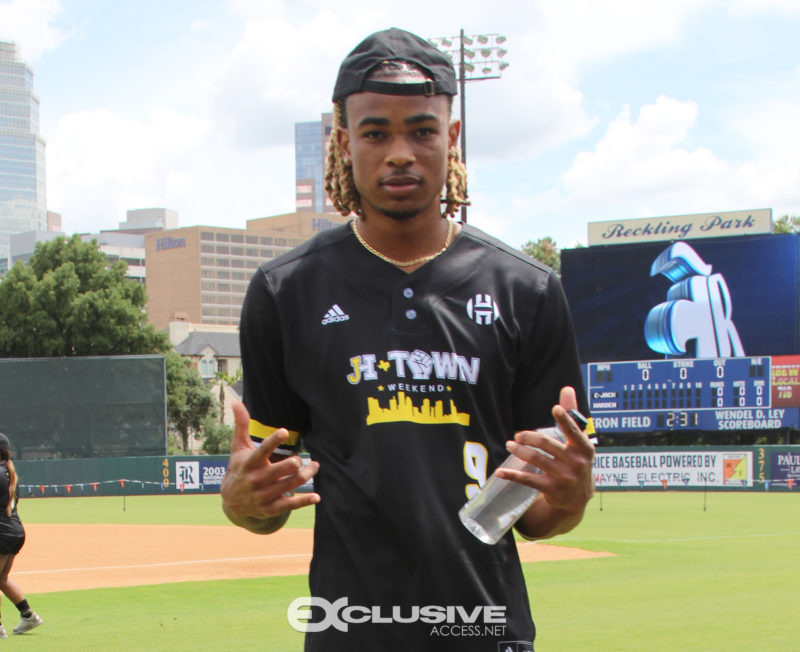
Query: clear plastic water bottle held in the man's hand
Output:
[[458, 410, 587, 545]]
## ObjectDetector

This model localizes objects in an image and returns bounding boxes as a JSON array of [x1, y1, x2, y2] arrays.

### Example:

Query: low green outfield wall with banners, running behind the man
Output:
[[10, 446, 800, 498]]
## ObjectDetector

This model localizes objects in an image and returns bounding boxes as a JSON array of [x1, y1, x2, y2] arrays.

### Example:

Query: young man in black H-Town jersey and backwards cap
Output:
[[222, 29, 594, 652]]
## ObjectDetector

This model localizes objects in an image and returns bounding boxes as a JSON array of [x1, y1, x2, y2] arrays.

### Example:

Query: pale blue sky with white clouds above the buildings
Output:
[[0, 0, 800, 247]]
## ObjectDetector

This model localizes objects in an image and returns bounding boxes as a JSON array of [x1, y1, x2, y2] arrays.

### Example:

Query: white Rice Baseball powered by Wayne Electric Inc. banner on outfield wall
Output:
[[593, 448, 753, 489]]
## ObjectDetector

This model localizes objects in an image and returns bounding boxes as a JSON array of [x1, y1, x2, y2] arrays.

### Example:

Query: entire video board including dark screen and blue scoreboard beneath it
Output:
[[562, 234, 800, 433]]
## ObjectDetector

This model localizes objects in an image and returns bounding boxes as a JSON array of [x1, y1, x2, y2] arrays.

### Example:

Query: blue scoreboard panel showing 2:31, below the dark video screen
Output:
[[586, 356, 800, 432]]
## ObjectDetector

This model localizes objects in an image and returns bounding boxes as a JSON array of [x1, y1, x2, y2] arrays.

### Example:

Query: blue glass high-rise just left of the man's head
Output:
[[294, 113, 337, 213]]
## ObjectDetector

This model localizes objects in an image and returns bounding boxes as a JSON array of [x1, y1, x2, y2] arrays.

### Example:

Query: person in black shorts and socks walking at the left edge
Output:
[[0, 433, 44, 638]]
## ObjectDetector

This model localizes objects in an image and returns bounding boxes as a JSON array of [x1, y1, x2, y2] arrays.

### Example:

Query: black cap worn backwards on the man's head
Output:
[[333, 27, 457, 102]]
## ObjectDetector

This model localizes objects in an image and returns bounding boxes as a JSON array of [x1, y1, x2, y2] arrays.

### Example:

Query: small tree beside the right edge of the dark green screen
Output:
[[167, 350, 217, 453]]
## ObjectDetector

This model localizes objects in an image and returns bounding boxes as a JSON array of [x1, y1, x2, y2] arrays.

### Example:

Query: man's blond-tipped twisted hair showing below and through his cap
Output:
[[325, 61, 468, 216]]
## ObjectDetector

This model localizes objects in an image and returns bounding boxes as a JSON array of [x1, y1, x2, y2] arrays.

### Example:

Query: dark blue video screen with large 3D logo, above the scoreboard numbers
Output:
[[561, 234, 800, 362]]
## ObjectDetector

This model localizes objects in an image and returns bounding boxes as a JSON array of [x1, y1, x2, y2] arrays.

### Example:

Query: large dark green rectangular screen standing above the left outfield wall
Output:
[[0, 355, 167, 460]]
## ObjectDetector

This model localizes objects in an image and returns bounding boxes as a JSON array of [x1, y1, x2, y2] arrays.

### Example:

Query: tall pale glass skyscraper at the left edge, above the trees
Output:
[[0, 41, 48, 267]]
